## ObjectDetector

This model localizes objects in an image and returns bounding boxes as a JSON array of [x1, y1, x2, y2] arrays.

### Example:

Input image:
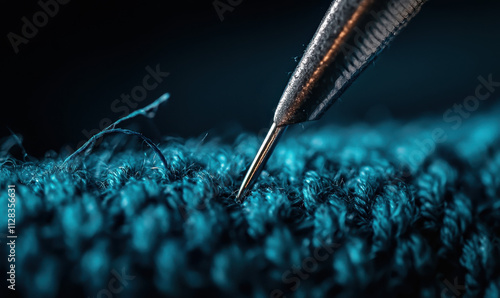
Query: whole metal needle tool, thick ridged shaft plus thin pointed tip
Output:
[[237, 0, 426, 200]]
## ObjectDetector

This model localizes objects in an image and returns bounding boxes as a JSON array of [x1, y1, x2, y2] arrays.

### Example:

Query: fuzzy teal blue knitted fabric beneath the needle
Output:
[[0, 101, 500, 297]]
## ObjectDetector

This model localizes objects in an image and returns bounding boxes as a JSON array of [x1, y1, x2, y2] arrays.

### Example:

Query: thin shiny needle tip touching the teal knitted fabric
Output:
[[236, 123, 287, 202]]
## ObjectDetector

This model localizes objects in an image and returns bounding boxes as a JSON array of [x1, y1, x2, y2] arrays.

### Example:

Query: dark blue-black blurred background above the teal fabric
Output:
[[0, 0, 500, 156]]
